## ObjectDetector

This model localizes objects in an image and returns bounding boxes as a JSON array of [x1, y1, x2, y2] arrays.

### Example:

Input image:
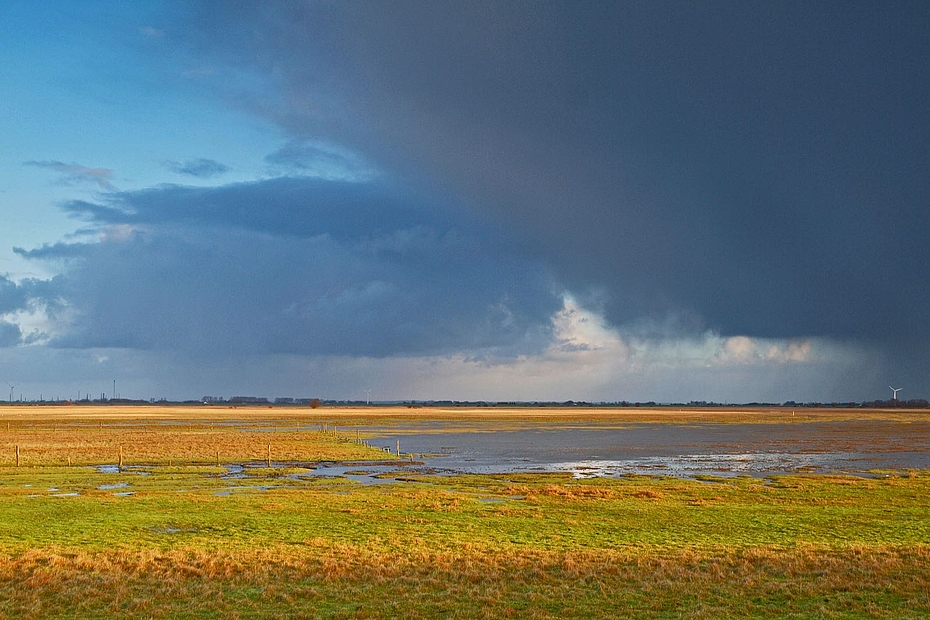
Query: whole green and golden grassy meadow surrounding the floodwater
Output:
[[0, 407, 930, 618]]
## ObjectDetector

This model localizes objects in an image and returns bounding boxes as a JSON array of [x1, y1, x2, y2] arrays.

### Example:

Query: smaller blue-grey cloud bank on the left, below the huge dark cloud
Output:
[[20, 178, 561, 357]]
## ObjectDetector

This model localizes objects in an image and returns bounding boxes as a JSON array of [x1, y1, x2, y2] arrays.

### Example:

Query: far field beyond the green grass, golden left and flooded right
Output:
[[0, 406, 930, 482]]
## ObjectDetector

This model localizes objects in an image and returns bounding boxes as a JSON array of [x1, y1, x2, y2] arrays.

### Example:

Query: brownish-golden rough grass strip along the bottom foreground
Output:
[[0, 539, 930, 619]]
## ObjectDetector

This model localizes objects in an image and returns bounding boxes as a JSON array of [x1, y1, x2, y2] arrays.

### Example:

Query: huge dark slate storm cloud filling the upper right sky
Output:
[[175, 1, 930, 354]]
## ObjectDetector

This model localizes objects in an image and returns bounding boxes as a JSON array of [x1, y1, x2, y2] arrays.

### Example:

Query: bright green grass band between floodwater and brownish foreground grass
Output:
[[0, 466, 930, 553]]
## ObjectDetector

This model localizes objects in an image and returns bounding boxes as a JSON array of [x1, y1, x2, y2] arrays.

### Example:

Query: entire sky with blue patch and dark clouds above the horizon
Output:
[[0, 0, 930, 403]]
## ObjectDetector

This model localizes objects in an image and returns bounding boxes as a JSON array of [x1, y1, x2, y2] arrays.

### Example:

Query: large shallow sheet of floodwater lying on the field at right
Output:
[[342, 420, 930, 478]]
